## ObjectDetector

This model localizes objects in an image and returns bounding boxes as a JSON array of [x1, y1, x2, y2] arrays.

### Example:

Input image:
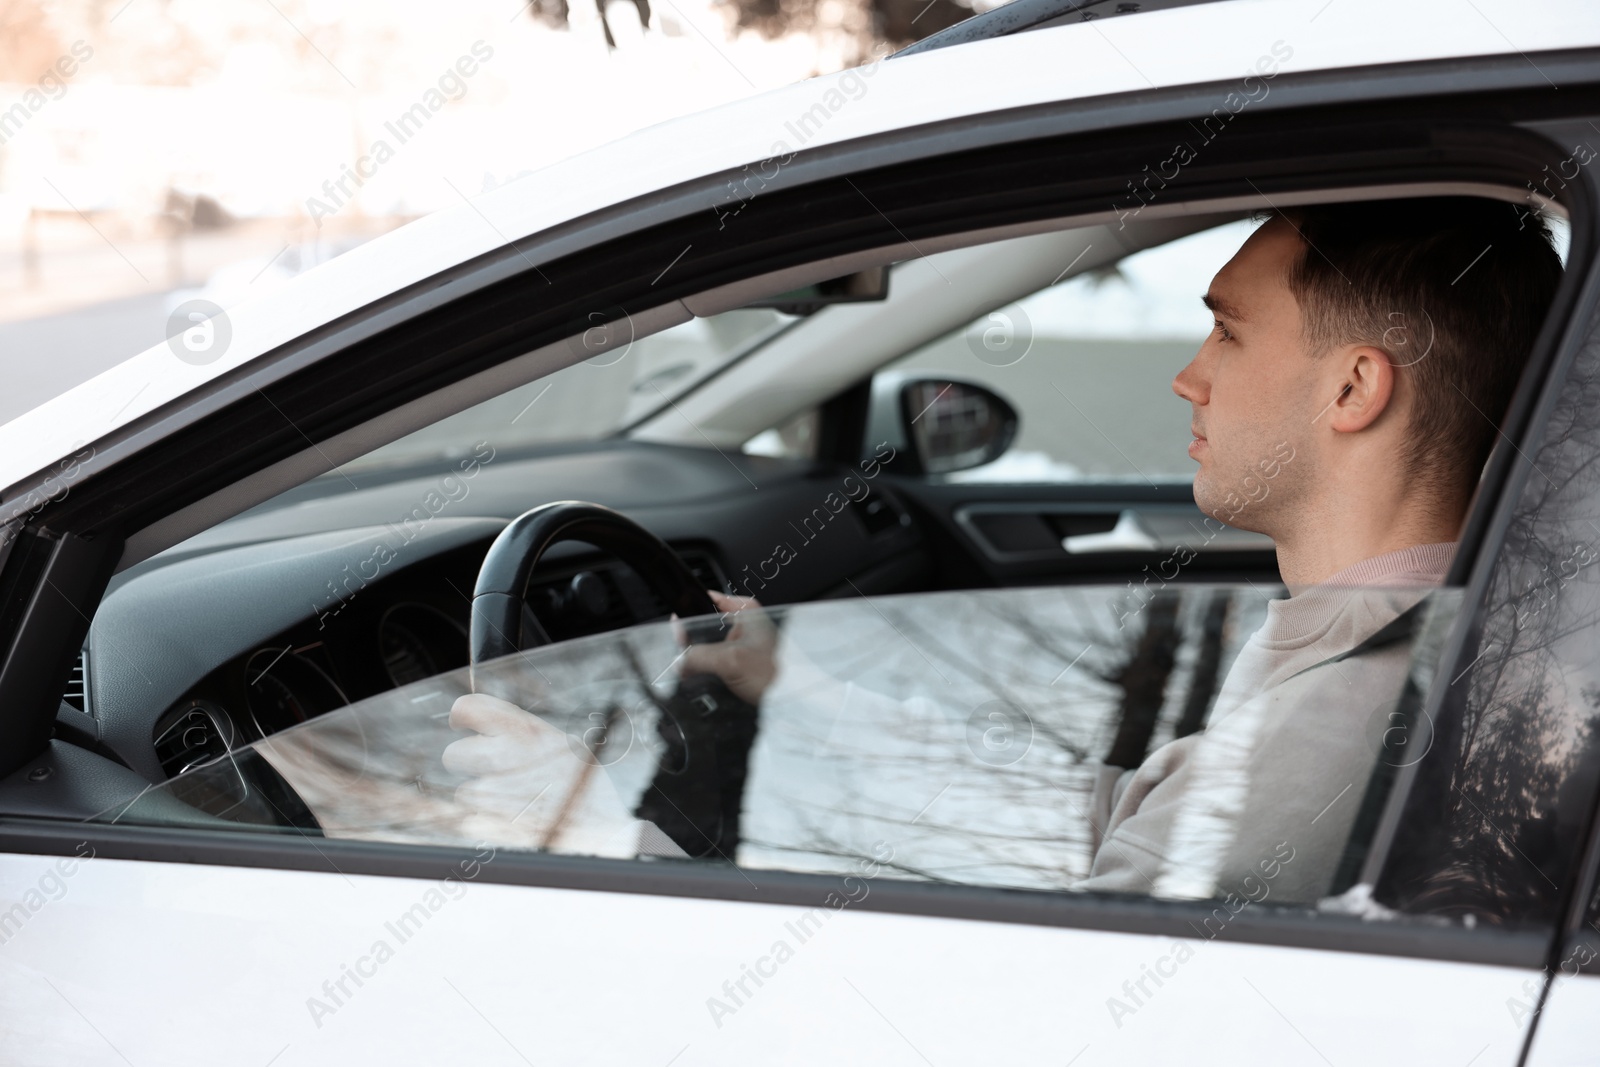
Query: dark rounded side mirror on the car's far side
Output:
[[899, 378, 1018, 474]]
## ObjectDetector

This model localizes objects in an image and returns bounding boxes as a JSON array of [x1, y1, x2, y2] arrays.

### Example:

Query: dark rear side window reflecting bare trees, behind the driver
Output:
[[1379, 295, 1600, 925]]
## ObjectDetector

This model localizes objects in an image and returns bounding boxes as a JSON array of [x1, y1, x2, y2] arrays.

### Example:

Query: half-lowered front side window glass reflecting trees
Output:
[[104, 585, 1458, 902]]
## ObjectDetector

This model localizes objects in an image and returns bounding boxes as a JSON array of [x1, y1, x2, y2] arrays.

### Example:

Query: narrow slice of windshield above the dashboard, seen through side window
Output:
[[337, 307, 795, 478]]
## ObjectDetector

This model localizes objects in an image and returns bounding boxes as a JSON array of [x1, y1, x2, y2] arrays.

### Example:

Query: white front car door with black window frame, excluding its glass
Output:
[[0, 18, 1594, 1064]]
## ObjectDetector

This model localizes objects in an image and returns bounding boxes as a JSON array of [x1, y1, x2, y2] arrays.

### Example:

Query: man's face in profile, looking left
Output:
[[1173, 219, 1318, 536]]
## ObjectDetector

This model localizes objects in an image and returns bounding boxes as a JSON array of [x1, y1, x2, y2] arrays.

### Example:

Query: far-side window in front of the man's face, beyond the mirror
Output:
[[880, 219, 1254, 485]]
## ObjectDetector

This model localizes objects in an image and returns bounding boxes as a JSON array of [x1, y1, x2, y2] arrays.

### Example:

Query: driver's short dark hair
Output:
[[1267, 197, 1562, 499]]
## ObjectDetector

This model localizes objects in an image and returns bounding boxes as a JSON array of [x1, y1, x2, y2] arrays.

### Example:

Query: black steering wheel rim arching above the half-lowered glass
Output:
[[469, 501, 726, 667]]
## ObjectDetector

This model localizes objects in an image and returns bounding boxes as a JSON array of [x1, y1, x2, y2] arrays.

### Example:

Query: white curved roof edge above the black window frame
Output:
[[0, 0, 1600, 502]]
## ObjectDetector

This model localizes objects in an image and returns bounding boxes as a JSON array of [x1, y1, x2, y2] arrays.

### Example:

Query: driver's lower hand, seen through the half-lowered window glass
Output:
[[443, 693, 638, 856]]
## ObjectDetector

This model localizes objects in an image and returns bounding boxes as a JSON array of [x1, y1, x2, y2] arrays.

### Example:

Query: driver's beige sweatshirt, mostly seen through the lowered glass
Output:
[[1074, 544, 1456, 902]]
